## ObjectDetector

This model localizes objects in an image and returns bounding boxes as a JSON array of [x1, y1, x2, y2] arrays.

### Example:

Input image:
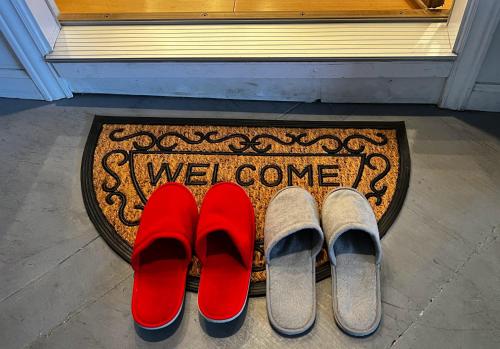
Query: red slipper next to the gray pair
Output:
[[195, 183, 255, 323]]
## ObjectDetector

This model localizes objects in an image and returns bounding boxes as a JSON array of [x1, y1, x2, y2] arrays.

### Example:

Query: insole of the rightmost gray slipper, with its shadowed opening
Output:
[[333, 231, 380, 332]]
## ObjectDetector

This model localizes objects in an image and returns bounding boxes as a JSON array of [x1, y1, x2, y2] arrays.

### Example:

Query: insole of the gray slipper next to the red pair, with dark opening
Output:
[[267, 229, 317, 333]]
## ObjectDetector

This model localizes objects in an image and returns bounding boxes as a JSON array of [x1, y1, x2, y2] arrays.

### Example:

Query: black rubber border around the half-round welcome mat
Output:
[[80, 115, 411, 296]]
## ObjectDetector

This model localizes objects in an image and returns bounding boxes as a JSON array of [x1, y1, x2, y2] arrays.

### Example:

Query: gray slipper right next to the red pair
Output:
[[264, 187, 324, 335]]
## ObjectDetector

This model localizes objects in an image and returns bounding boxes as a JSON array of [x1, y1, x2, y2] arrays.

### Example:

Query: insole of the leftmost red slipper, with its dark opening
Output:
[[133, 239, 190, 326]]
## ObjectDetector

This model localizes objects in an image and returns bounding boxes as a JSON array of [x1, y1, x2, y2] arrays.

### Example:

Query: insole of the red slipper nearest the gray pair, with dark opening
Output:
[[198, 231, 250, 320]]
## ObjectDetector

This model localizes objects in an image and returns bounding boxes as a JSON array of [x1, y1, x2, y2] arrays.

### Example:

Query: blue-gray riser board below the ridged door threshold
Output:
[[54, 61, 452, 104]]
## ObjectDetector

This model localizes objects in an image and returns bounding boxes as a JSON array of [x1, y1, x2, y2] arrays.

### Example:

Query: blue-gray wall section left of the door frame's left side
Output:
[[0, 33, 43, 99]]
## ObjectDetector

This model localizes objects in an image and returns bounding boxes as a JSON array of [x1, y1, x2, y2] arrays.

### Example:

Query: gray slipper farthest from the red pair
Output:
[[321, 188, 382, 336]]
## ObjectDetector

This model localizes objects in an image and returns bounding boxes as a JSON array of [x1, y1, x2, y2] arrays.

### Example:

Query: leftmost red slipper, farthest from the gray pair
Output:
[[132, 183, 198, 330]]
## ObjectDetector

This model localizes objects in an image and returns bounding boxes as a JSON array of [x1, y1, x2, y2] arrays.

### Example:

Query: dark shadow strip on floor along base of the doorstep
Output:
[[0, 95, 500, 138]]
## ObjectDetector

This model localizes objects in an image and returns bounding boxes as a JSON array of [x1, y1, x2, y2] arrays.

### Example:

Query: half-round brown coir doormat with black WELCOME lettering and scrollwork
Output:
[[81, 116, 410, 296]]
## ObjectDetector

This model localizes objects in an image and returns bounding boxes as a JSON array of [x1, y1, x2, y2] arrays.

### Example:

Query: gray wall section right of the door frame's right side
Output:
[[467, 21, 500, 111]]
